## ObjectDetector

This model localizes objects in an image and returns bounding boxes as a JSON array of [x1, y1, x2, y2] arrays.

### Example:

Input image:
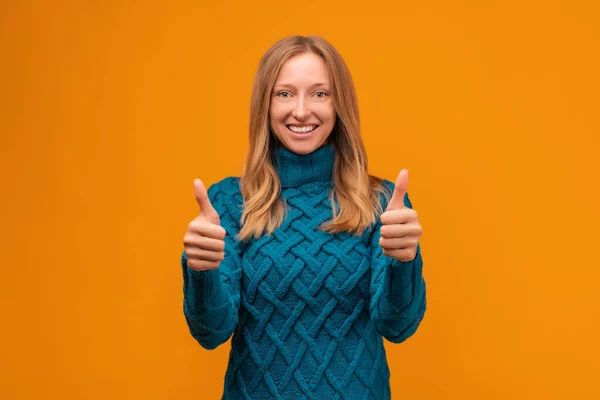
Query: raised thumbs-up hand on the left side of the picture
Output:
[[183, 179, 226, 271]]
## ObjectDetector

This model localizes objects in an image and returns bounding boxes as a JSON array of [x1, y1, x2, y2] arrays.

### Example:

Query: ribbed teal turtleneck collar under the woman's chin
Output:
[[274, 143, 335, 188]]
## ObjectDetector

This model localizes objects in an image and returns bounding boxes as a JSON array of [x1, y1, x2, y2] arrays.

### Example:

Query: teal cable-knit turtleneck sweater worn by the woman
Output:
[[181, 144, 426, 400]]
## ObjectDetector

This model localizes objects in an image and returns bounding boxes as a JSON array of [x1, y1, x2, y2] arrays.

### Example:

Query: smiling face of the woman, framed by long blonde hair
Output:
[[269, 53, 336, 154]]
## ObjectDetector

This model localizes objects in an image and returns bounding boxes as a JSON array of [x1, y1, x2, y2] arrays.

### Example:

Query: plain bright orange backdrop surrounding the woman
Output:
[[0, 0, 600, 399]]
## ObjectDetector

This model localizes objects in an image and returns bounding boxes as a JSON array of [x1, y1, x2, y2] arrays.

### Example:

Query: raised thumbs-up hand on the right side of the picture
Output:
[[379, 169, 423, 262]]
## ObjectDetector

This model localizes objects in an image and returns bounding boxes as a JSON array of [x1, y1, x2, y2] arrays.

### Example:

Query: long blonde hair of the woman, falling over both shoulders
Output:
[[238, 36, 391, 241]]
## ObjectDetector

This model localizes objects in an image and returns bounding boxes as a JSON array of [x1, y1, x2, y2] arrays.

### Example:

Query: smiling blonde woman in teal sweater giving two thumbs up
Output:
[[181, 36, 426, 399]]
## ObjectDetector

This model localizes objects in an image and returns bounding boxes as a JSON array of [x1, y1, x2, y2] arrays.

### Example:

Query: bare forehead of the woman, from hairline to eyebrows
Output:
[[276, 53, 329, 84]]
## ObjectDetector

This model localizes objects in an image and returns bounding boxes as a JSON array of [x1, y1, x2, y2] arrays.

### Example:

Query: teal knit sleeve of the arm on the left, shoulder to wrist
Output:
[[181, 177, 244, 350]]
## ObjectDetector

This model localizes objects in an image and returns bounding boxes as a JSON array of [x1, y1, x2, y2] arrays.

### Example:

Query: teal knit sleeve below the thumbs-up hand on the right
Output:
[[369, 180, 426, 343]]
